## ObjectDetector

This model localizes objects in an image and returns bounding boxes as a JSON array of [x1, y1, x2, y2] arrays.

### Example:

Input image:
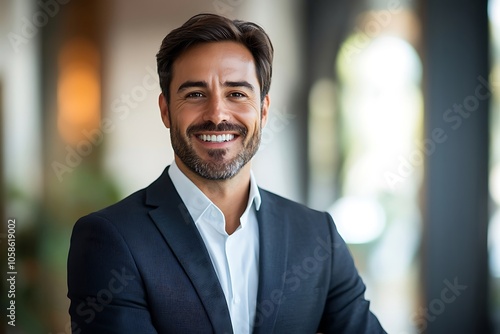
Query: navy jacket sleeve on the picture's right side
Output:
[[318, 214, 385, 334]]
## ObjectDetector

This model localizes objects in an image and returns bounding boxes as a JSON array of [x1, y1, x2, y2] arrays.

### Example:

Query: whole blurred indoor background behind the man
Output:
[[0, 0, 500, 334]]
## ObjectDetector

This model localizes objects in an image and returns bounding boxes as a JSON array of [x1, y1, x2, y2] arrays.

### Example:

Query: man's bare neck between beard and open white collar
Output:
[[175, 156, 251, 234]]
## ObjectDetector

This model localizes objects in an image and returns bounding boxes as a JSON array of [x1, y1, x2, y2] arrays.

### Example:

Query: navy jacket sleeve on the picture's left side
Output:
[[68, 214, 156, 334]]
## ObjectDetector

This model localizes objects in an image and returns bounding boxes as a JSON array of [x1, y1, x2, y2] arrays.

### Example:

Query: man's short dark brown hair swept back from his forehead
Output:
[[156, 14, 274, 102]]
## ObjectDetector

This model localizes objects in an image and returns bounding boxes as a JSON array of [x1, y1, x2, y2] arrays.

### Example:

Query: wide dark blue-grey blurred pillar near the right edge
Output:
[[417, 0, 491, 333]]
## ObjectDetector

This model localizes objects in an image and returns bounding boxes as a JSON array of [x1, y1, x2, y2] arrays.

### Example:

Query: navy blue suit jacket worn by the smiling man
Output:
[[68, 168, 384, 334]]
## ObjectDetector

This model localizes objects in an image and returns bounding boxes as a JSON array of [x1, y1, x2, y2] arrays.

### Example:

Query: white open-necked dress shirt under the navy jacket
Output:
[[168, 161, 261, 334]]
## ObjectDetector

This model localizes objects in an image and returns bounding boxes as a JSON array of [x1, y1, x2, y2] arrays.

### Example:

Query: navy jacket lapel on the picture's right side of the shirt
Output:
[[253, 190, 288, 334]]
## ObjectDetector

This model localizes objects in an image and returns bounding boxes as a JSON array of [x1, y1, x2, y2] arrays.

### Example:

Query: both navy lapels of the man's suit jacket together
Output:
[[146, 167, 288, 333]]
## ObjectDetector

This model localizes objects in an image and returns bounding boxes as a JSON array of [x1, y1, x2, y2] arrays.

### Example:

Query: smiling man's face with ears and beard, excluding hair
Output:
[[160, 42, 269, 180]]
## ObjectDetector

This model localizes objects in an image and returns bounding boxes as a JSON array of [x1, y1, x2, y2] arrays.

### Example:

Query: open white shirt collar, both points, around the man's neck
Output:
[[168, 160, 262, 225]]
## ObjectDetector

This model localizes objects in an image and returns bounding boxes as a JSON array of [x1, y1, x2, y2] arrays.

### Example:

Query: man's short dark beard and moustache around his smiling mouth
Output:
[[170, 122, 262, 180]]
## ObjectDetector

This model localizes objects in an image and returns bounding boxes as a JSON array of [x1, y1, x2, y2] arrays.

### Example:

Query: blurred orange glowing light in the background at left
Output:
[[57, 41, 101, 145]]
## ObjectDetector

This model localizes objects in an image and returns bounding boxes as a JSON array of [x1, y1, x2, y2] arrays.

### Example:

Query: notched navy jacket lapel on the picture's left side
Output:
[[146, 168, 232, 333]]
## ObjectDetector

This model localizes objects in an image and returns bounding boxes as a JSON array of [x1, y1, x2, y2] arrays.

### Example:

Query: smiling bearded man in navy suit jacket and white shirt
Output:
[[68, 14, 384, 334]]
